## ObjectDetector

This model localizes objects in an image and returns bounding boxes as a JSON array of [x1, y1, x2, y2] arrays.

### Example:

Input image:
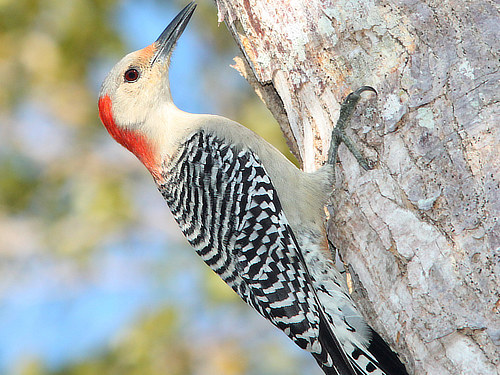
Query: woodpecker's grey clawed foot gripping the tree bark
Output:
[[328, 86, 377, 171]]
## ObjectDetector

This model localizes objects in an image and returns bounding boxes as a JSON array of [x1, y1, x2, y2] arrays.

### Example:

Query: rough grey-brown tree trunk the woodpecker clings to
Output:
[[216, 0, 500, 375]]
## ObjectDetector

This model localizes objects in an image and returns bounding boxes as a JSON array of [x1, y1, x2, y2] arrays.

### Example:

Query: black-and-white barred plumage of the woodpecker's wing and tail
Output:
[[154, 130, 404, 374]]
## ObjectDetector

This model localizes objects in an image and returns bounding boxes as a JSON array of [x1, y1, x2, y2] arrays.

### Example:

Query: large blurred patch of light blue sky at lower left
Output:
[[0, 240, 174, 368]]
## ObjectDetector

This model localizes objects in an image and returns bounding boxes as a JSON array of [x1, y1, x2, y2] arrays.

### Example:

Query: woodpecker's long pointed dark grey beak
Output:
[[151, 1, 196, 65]]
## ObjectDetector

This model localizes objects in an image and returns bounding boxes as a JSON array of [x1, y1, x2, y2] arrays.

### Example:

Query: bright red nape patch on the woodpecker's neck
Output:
[[99, 95, 159, 176]]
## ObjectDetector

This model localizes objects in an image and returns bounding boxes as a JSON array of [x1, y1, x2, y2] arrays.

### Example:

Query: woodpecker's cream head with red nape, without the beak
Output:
[[99, 43, 201, 176]]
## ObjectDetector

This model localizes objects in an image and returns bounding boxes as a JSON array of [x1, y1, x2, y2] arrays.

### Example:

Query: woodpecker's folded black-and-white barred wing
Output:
[[159, 132, 328, 353]]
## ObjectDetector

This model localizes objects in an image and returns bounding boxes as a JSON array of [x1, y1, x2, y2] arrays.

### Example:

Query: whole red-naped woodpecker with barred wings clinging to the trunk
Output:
[[99, 2, 407, 375]]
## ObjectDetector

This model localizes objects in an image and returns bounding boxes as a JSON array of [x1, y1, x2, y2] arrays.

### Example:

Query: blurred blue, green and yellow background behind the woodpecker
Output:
[[0, 0, 320, 375]]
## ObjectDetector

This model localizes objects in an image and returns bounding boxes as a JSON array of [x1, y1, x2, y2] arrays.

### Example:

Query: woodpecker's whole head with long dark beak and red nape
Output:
[[99, 1, 196, 177]]
